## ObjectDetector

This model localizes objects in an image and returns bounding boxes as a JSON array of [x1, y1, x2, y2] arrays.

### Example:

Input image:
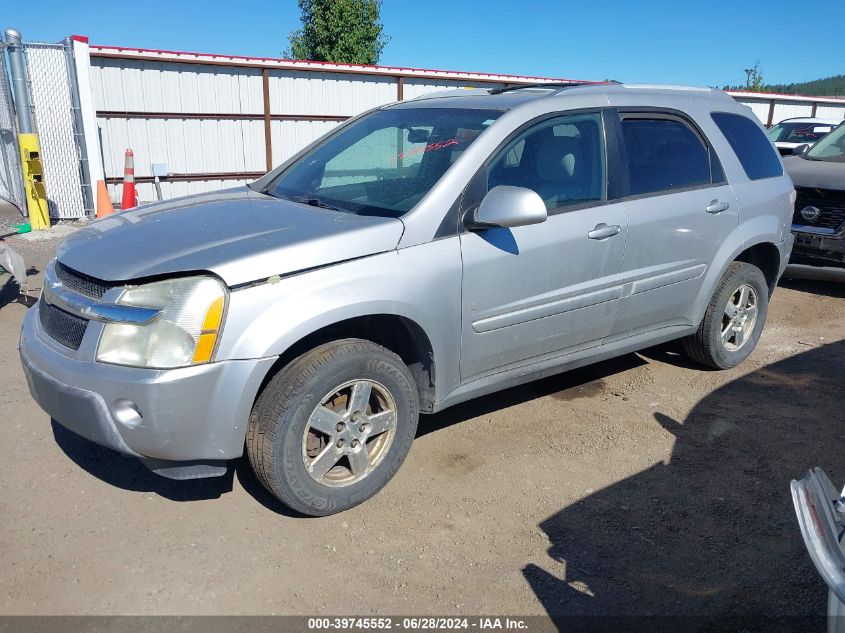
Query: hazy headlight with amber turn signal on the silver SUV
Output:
[[97, 277, 226, 369]]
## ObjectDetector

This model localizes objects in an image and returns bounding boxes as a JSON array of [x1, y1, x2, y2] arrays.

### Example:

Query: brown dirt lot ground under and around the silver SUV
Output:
[[0, 211, 845, 615]]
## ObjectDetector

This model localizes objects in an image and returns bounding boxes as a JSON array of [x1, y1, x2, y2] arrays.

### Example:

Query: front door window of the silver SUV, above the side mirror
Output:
[[487, 113, 607, 211]]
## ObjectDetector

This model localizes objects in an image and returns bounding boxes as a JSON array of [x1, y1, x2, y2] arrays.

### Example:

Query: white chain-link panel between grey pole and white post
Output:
[[24, 42, 86, 219]]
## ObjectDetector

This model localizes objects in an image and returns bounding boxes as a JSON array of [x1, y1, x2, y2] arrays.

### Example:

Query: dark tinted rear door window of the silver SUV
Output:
[[622, 114, 719, 196]]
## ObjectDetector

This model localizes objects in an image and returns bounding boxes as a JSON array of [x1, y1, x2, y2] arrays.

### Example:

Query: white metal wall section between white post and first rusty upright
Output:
[[91, 59, 264, 201]]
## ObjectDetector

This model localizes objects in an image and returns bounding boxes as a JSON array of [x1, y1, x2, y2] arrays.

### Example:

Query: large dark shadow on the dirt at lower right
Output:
[[523, 342, 845, 631]]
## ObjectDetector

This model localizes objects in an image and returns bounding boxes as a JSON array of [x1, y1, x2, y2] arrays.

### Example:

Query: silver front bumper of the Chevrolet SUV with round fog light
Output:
[[20, 308, 275, 464]]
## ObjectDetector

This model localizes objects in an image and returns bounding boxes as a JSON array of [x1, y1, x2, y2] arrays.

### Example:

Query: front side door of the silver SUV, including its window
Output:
[[454, 112, 627, 382]]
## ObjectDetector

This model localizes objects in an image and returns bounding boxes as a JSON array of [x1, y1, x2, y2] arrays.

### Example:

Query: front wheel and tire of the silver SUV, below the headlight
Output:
[[246, 339, 419, 516]]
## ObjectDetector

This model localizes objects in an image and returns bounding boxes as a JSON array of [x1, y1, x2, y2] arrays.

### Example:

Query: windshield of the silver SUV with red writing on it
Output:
[[265, 108, 502, 217]]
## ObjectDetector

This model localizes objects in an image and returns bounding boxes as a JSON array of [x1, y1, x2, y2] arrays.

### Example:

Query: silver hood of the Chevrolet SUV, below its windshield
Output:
[[57, 187, 404, 286]]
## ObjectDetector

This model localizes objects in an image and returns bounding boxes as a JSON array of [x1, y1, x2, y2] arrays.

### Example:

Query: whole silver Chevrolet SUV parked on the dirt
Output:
[[20, 84, 794, 515]]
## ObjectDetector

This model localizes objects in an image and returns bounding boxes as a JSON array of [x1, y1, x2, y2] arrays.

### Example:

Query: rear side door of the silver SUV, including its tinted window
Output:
[[610, 110, 739, 337]]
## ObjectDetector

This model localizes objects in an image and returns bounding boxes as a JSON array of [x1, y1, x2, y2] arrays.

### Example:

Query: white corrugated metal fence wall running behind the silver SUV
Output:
[[91, 47, 845, 201]]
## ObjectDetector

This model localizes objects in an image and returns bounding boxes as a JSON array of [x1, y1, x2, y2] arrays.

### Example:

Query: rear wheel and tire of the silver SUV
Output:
[[683, 262, 769, 369]]
